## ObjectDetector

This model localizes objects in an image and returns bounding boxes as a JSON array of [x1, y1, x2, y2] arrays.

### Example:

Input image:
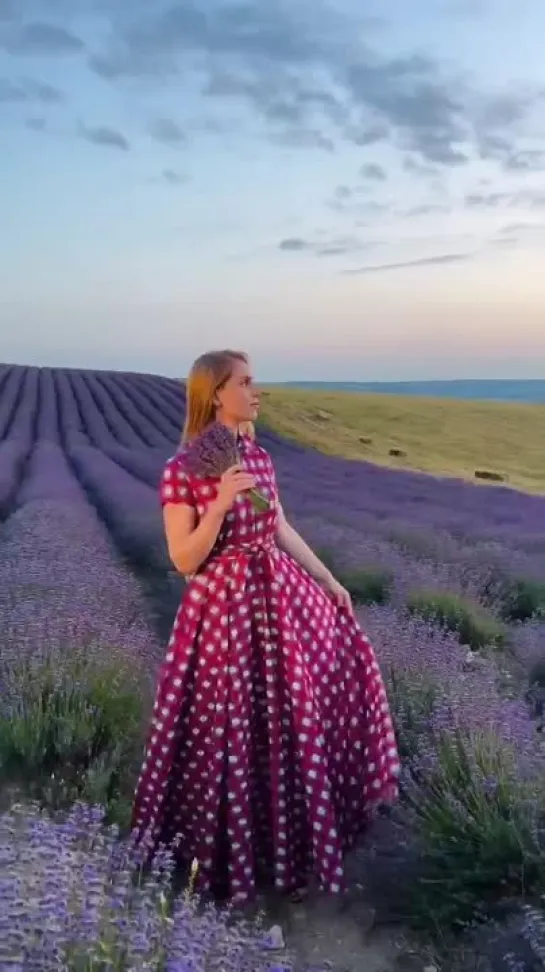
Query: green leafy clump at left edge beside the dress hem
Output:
[[0, 655, 143, 824]]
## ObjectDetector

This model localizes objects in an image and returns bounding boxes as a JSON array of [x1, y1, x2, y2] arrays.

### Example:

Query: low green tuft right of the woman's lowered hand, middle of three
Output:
[[407, 591, 507, 651]]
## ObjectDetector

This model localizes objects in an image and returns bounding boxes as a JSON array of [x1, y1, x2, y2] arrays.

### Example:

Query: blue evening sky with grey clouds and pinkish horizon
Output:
[[0, 0, 545, 381]]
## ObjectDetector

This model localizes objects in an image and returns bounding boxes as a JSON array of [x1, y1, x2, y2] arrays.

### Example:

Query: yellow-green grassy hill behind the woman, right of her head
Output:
[[261, 387, 545, 493]]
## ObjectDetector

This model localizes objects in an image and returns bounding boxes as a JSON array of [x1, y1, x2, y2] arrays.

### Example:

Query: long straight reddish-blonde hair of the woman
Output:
[[182, 348, 248, 442]]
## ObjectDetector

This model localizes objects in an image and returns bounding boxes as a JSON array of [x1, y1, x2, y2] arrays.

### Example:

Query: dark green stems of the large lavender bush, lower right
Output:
[[408, 730, 545, 928]]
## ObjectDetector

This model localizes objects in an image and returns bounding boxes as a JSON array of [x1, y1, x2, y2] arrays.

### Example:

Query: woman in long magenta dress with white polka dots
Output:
[[133, 351, 399, 900]]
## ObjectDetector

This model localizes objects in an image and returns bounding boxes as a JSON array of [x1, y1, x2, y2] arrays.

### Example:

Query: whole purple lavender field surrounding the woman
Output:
[[0, 366, 545, 972]]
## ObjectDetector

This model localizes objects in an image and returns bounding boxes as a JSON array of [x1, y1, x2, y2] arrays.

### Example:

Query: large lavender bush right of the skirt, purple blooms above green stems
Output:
[[362, 607, 545, 927]]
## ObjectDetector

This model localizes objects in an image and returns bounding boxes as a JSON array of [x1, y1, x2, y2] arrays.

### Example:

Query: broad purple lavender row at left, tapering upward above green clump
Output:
[[0, 444, 163, 672]]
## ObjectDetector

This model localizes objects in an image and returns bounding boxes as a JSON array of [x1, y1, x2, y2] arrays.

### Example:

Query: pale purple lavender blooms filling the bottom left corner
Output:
[[0, 805, 276, 972]]
